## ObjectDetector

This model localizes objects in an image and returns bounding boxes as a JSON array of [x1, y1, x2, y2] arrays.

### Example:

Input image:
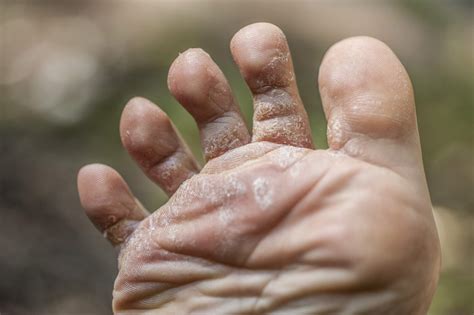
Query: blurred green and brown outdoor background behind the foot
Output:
[[0, 0, 474, 315]]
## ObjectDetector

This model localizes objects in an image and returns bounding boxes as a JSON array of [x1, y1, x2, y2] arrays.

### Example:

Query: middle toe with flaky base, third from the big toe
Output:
[[168, 49, 250, 160]]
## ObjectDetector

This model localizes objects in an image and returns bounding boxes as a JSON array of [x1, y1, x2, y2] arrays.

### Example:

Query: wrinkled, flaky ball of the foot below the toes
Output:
[[114, 142, 438, 314]]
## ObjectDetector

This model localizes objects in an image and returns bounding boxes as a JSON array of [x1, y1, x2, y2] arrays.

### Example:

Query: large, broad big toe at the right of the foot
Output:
[[319, 37, 421, 174]]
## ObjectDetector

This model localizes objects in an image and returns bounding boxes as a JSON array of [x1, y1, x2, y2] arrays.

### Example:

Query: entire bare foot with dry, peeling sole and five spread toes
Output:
[[78, 23, 440, 315]]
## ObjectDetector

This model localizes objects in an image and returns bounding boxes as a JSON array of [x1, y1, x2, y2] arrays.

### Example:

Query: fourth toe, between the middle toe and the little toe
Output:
[[120, 97, 199, 195]]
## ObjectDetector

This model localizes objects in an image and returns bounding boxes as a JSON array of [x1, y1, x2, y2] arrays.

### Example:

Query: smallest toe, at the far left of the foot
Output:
[[77, 164, 148, 246]]
